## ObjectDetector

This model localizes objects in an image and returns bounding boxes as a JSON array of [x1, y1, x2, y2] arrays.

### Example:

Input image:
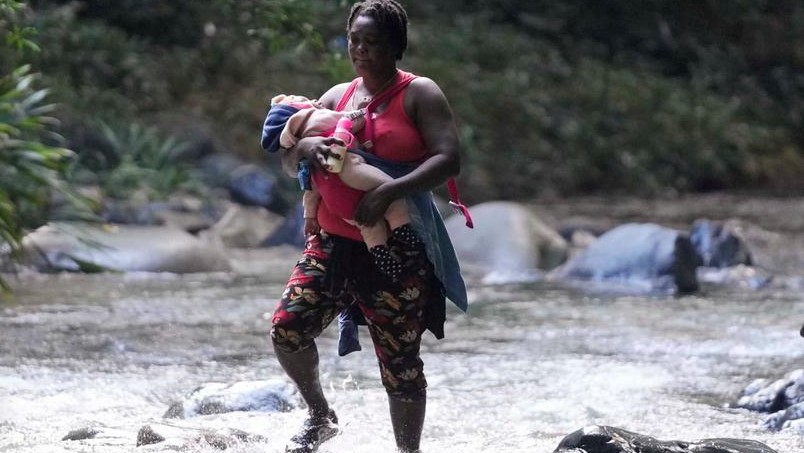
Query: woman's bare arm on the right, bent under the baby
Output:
[[355, 77, 460, 225]]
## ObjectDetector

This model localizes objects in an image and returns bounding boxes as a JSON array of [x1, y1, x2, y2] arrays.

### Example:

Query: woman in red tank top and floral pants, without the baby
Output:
[[271, 0, 466, 453]]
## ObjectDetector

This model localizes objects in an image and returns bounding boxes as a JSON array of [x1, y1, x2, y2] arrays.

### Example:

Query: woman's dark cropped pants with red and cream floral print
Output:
[[271, 226, 436, 401]]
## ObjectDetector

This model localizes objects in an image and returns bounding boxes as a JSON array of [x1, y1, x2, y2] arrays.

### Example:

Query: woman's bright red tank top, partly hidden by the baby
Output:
[[313, 71, 427, 241]]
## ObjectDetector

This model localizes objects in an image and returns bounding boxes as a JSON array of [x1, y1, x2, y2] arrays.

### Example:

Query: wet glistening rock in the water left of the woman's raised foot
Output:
[[164, 380, 297, 418]]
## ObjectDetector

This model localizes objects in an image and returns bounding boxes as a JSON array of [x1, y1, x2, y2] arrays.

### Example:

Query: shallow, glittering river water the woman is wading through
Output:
[[0, 196, 804, 453]]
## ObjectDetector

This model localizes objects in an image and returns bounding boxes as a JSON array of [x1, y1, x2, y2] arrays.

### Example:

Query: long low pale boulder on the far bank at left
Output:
[[22, 222, 231, 273]]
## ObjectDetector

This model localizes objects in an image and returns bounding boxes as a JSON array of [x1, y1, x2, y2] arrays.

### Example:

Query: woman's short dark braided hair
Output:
[[346, 0, 408, 60]]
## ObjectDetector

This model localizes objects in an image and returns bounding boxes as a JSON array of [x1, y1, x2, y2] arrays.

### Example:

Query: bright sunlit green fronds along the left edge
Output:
[[0, 0, 98, 291]]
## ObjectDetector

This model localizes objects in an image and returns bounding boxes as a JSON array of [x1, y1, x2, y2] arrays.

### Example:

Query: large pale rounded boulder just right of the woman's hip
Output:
[[445, 201, 569, 283]]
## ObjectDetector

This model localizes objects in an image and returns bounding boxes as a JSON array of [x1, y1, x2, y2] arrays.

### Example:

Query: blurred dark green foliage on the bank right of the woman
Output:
[[410, 1, 804, 201]]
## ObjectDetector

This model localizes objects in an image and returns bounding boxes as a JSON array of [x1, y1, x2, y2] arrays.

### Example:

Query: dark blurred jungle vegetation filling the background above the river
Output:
[[0, 0, 804, 262]]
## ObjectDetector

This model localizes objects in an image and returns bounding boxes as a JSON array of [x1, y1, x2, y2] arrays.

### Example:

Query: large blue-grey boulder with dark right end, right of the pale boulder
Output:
[[548, 223, 701, 293]]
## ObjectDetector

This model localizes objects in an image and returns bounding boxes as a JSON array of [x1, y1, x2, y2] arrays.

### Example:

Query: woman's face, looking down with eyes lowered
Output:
[[348, 16, 396, 75]]
